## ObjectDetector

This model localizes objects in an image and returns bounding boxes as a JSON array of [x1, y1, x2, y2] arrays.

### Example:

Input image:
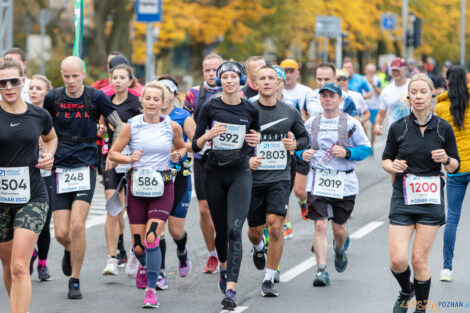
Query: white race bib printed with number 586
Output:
[[131, 168, 165, 198]]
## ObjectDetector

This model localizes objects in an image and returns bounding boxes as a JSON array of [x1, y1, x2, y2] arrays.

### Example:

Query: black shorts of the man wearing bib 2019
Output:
[[307, 193, 356, 225]]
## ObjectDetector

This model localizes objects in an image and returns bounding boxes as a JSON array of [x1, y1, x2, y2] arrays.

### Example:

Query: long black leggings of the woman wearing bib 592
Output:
[[204, 162, 252, 282]]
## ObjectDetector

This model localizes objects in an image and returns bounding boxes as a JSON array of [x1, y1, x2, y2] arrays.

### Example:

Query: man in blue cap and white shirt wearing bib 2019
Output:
[[302, 82, 372, 287]]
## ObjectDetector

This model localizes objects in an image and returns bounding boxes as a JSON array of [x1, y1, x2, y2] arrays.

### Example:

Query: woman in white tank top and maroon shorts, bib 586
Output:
[[109, 81, 186, 308]]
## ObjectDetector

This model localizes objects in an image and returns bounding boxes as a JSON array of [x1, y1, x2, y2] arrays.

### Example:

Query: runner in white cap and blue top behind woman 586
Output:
[[157, 75, 196, 290]]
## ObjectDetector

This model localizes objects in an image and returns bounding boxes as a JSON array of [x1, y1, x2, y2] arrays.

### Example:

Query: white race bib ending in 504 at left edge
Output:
[[0, 166, 31, 203]]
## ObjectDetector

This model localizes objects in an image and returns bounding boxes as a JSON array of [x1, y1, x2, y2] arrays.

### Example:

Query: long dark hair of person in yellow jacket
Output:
[[446, 66, 470, 129]]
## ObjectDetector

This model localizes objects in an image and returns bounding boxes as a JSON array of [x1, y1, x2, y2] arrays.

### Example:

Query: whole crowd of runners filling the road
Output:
[[0, 48, 470, 313]]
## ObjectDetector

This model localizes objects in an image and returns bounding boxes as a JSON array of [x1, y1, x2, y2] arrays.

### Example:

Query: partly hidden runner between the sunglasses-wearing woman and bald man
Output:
[[29, 74, 54, 281]]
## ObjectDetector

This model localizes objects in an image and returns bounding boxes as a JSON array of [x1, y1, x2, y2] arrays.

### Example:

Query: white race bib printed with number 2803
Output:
[[256, 141, 288, 170]]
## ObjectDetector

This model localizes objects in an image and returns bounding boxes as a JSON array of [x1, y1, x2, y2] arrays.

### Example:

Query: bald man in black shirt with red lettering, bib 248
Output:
[[44, 56, 122, 299]]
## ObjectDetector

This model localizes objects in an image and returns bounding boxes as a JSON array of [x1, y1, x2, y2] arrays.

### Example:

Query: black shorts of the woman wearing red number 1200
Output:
[[388, 188, 446, 226]]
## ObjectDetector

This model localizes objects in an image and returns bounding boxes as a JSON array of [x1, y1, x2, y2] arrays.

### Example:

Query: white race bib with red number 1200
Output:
[[403, 174, 441, 205]]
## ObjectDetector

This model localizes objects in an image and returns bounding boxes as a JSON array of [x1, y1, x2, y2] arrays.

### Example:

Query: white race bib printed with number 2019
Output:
[[313, 169, 346, 199]]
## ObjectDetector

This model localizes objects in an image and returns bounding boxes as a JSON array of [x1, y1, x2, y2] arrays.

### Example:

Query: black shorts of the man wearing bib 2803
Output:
[[248, 180, 290, 227]]
